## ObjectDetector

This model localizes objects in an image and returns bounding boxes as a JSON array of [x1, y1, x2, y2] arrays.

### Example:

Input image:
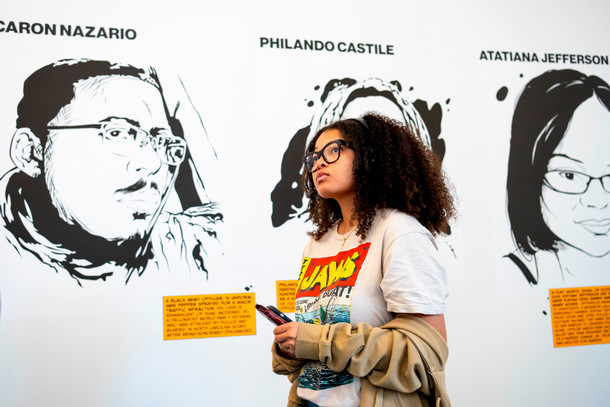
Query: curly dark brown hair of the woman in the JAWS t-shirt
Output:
[[302, 113, 455, 240]]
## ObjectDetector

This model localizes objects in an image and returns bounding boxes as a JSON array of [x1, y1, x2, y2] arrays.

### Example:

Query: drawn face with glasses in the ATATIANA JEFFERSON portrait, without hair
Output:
[[540, 97, 610, 257]]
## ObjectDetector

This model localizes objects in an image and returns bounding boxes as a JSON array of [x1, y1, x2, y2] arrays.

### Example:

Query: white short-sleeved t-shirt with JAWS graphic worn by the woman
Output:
[[295, 210, 448, 407]]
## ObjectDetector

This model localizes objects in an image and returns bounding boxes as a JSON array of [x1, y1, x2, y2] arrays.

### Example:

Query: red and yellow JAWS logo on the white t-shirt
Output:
[[296, 243, 371, 298]]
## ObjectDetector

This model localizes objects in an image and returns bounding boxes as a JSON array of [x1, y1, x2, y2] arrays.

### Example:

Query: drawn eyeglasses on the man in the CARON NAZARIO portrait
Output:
[[47, 122, 186, 165]]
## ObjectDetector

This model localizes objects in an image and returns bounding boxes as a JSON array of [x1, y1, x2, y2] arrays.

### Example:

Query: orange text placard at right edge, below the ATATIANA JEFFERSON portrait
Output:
[[549, 286, 610, 348]]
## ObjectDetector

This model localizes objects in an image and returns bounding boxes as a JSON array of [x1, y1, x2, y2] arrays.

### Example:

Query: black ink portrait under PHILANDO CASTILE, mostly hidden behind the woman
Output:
[[271, 78, 445, 227]]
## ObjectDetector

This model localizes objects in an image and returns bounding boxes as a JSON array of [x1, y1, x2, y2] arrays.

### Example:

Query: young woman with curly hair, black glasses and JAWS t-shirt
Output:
[[273, 114, 454, 407]]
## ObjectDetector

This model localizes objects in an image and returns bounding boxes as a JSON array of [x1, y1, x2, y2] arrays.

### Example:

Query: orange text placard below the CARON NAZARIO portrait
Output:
[[163, 293, 256, 340]]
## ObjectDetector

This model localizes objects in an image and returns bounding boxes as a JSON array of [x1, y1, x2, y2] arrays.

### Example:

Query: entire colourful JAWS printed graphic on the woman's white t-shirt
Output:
[[295, 243, 371, 390]]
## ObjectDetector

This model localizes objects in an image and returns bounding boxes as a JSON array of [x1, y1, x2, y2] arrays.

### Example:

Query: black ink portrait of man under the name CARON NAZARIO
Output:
[[0, 60, 222, 285]]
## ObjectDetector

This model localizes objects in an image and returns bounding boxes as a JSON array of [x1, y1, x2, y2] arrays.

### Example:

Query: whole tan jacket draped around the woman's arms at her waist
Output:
[[272, 315, 451, 407]]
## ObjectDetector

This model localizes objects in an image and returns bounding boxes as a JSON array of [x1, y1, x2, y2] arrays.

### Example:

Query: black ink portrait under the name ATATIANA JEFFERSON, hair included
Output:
[[507, 69, 610, 286]]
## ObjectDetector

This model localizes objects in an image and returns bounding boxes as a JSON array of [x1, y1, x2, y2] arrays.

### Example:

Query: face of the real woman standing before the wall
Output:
[[311, 129, 355, 203]]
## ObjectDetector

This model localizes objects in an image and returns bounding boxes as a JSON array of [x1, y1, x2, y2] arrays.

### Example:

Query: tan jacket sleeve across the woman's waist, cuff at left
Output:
[[296, 316, 448, 394]]
